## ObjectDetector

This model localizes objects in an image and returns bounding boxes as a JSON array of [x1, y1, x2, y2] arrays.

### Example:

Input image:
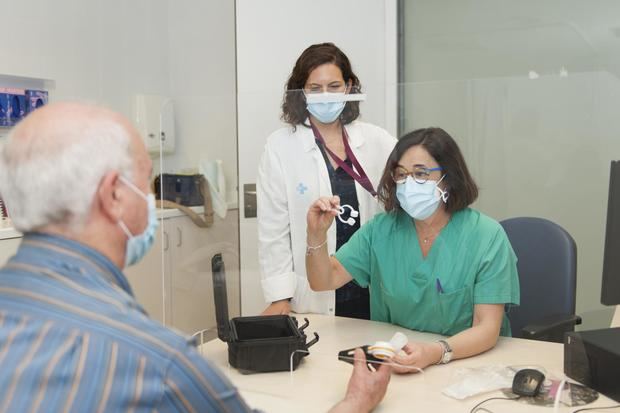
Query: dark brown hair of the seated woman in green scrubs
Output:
[[377, 128, 478, 213]]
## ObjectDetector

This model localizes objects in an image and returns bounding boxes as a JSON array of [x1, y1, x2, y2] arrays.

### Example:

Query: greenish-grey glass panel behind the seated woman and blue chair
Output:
[[399, 1, 620, 329]]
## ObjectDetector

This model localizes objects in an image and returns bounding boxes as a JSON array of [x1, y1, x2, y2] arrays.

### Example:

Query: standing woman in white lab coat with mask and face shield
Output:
[[257, 43, 396, 319]]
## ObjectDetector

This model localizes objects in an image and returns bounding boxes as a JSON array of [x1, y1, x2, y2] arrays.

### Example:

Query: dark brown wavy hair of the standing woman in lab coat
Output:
[[281, 43, 362, 128]]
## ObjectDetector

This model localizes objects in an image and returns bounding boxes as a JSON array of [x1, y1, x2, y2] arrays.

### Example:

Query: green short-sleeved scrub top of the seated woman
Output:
[[335, 208, 519, 336]]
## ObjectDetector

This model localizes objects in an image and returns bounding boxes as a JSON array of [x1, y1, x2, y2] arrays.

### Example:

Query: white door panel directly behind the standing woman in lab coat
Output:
[[237, 0, 396, 315]]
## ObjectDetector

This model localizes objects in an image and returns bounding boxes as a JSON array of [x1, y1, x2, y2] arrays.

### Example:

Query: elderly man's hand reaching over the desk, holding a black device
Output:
[[330, 348, 391, 413]]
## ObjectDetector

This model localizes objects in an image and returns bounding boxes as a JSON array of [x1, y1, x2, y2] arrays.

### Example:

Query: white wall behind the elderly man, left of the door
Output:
[[0, 0, 237, 200]]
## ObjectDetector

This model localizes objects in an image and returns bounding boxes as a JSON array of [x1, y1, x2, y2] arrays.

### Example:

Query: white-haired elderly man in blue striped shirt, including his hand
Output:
[[0, 103, 390, 413]]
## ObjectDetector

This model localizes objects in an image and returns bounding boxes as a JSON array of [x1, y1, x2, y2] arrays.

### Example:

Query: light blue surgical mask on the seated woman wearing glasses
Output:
[[396, 175, 448, 221]]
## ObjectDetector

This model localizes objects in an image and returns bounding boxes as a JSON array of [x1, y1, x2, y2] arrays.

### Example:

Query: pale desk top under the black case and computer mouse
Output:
[[200, 314, 617, 413]]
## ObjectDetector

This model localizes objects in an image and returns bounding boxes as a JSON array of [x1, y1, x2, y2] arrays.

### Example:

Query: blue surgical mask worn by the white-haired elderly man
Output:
[[118, 176, 159, 268]]
